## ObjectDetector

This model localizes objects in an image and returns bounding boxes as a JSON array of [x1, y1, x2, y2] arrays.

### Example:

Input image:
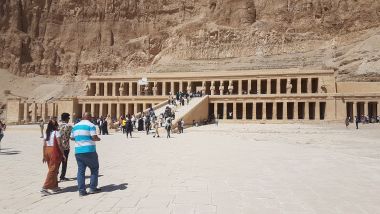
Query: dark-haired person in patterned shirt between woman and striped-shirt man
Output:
[[59, 113, 73, 181]]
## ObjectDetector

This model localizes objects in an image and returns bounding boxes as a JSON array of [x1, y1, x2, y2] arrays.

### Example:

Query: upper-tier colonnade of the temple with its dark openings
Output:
[[87, 77, 319, 96]]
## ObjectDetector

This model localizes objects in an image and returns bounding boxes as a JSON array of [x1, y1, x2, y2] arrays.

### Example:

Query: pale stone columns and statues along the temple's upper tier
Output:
[[89, 78, 317, 96]]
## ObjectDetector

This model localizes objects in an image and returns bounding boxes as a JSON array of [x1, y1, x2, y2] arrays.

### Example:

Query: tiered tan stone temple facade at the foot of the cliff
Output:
[[7, 69, 380, 124]]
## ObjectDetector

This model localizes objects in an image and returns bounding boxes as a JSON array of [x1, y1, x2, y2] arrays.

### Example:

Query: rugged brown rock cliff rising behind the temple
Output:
[[0, 0, 380, 80]]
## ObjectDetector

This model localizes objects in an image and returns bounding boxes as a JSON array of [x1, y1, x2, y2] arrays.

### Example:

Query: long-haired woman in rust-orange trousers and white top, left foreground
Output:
[[40, 120, 66, 195]]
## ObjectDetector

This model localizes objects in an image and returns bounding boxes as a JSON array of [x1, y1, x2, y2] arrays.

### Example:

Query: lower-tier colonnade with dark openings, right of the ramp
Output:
[[209, 101, 327, 120]]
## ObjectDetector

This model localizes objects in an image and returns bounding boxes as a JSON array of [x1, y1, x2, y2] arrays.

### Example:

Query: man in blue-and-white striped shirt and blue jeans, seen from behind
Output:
[[71, 112, 100, 196]]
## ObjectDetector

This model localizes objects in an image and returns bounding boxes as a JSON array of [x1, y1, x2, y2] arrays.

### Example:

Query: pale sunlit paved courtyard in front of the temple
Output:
[[0, 124, 380, 214]]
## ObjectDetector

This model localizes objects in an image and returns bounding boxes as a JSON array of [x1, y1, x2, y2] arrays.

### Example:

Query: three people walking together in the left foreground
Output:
[[40, 113, 100, 196]]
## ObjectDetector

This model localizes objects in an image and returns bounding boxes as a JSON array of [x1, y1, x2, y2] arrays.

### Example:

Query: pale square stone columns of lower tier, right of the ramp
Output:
[[214, 102, 326, 120]]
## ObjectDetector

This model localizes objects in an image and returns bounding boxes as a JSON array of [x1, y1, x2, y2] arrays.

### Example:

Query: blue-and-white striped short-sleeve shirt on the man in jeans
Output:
[[71, 120, 96, 154]]
